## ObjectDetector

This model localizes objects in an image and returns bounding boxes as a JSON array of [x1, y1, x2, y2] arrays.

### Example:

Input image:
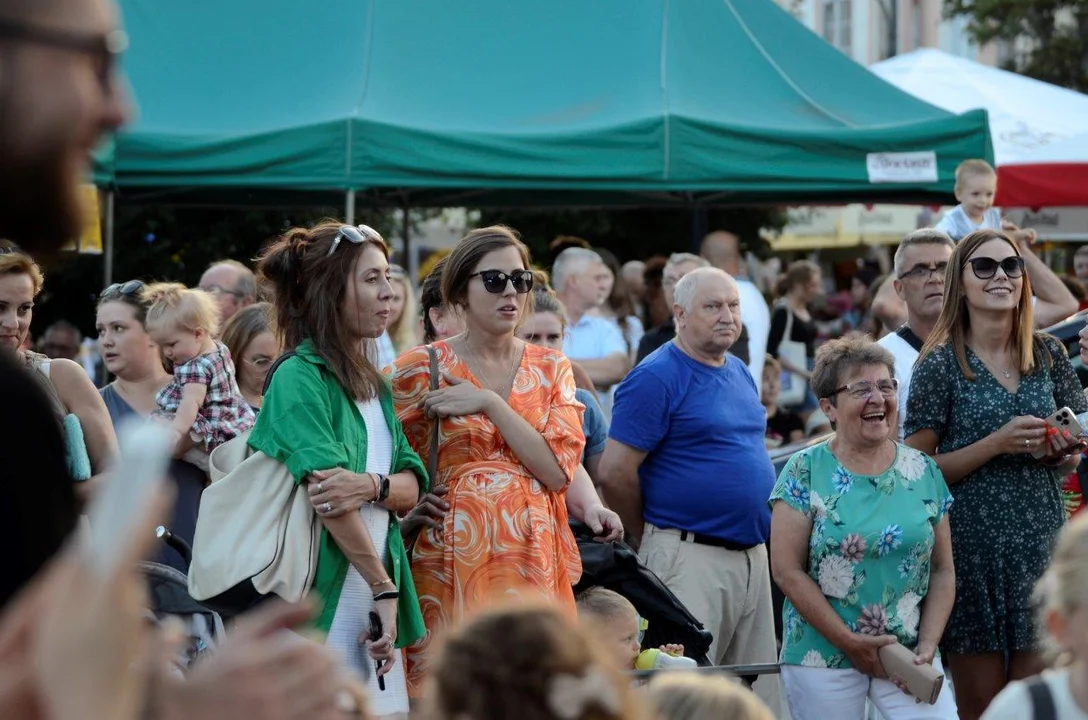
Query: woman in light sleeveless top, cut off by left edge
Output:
[[0, 246, 118, 499]]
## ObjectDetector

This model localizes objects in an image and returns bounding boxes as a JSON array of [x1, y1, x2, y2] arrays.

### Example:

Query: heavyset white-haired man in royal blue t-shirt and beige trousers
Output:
[[599, 268, 776, 678]]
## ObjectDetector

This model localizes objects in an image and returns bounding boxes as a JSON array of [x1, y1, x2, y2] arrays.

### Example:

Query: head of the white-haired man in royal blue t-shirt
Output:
[[673, 273, 741, 357]]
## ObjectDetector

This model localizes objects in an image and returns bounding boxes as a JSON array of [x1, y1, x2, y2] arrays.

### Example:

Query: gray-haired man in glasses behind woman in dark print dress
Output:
[[878, 227, 955, 439]]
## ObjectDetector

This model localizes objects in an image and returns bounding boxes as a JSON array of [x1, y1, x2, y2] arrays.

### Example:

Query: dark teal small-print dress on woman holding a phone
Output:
[[904, 334, 1088, 655]]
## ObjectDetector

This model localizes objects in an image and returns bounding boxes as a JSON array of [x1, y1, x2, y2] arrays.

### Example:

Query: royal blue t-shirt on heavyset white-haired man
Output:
[[609, 343, 775, 545]]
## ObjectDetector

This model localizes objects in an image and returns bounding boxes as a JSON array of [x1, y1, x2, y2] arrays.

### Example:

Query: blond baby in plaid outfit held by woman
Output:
[[143, 283, 257, 470]]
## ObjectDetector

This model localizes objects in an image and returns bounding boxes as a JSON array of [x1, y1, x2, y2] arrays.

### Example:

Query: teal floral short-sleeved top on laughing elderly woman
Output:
[[770, 442, 952, 669]]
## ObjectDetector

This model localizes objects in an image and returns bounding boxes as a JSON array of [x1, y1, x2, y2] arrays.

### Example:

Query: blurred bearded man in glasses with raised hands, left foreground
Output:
[[0, 0, 376, 720]]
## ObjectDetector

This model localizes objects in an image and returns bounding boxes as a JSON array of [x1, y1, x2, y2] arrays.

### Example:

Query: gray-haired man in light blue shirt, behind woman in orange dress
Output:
[[552, 248, 631, 402]]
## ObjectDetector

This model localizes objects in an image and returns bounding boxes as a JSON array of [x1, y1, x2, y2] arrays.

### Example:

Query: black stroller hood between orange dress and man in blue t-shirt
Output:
[[570, 522, 713, 667]]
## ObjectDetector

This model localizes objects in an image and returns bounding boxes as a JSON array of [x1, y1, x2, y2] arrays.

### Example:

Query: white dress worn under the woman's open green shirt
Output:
[[325, 398, 408, 717]]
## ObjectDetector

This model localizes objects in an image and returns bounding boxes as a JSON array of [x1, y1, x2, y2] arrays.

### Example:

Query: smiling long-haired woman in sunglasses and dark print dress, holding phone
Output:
[[904, 229, 1088, 719]]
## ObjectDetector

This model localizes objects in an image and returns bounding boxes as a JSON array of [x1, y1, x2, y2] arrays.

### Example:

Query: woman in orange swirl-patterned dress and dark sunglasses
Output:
[[393, 226, 585, 696]]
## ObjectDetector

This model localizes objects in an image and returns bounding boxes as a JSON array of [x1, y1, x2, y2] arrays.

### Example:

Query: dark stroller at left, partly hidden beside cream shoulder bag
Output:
[[139, 526, 225, 669]]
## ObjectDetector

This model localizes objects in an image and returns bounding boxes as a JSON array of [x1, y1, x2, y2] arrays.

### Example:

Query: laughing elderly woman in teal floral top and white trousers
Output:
[[770, 333, 956, 720]]
